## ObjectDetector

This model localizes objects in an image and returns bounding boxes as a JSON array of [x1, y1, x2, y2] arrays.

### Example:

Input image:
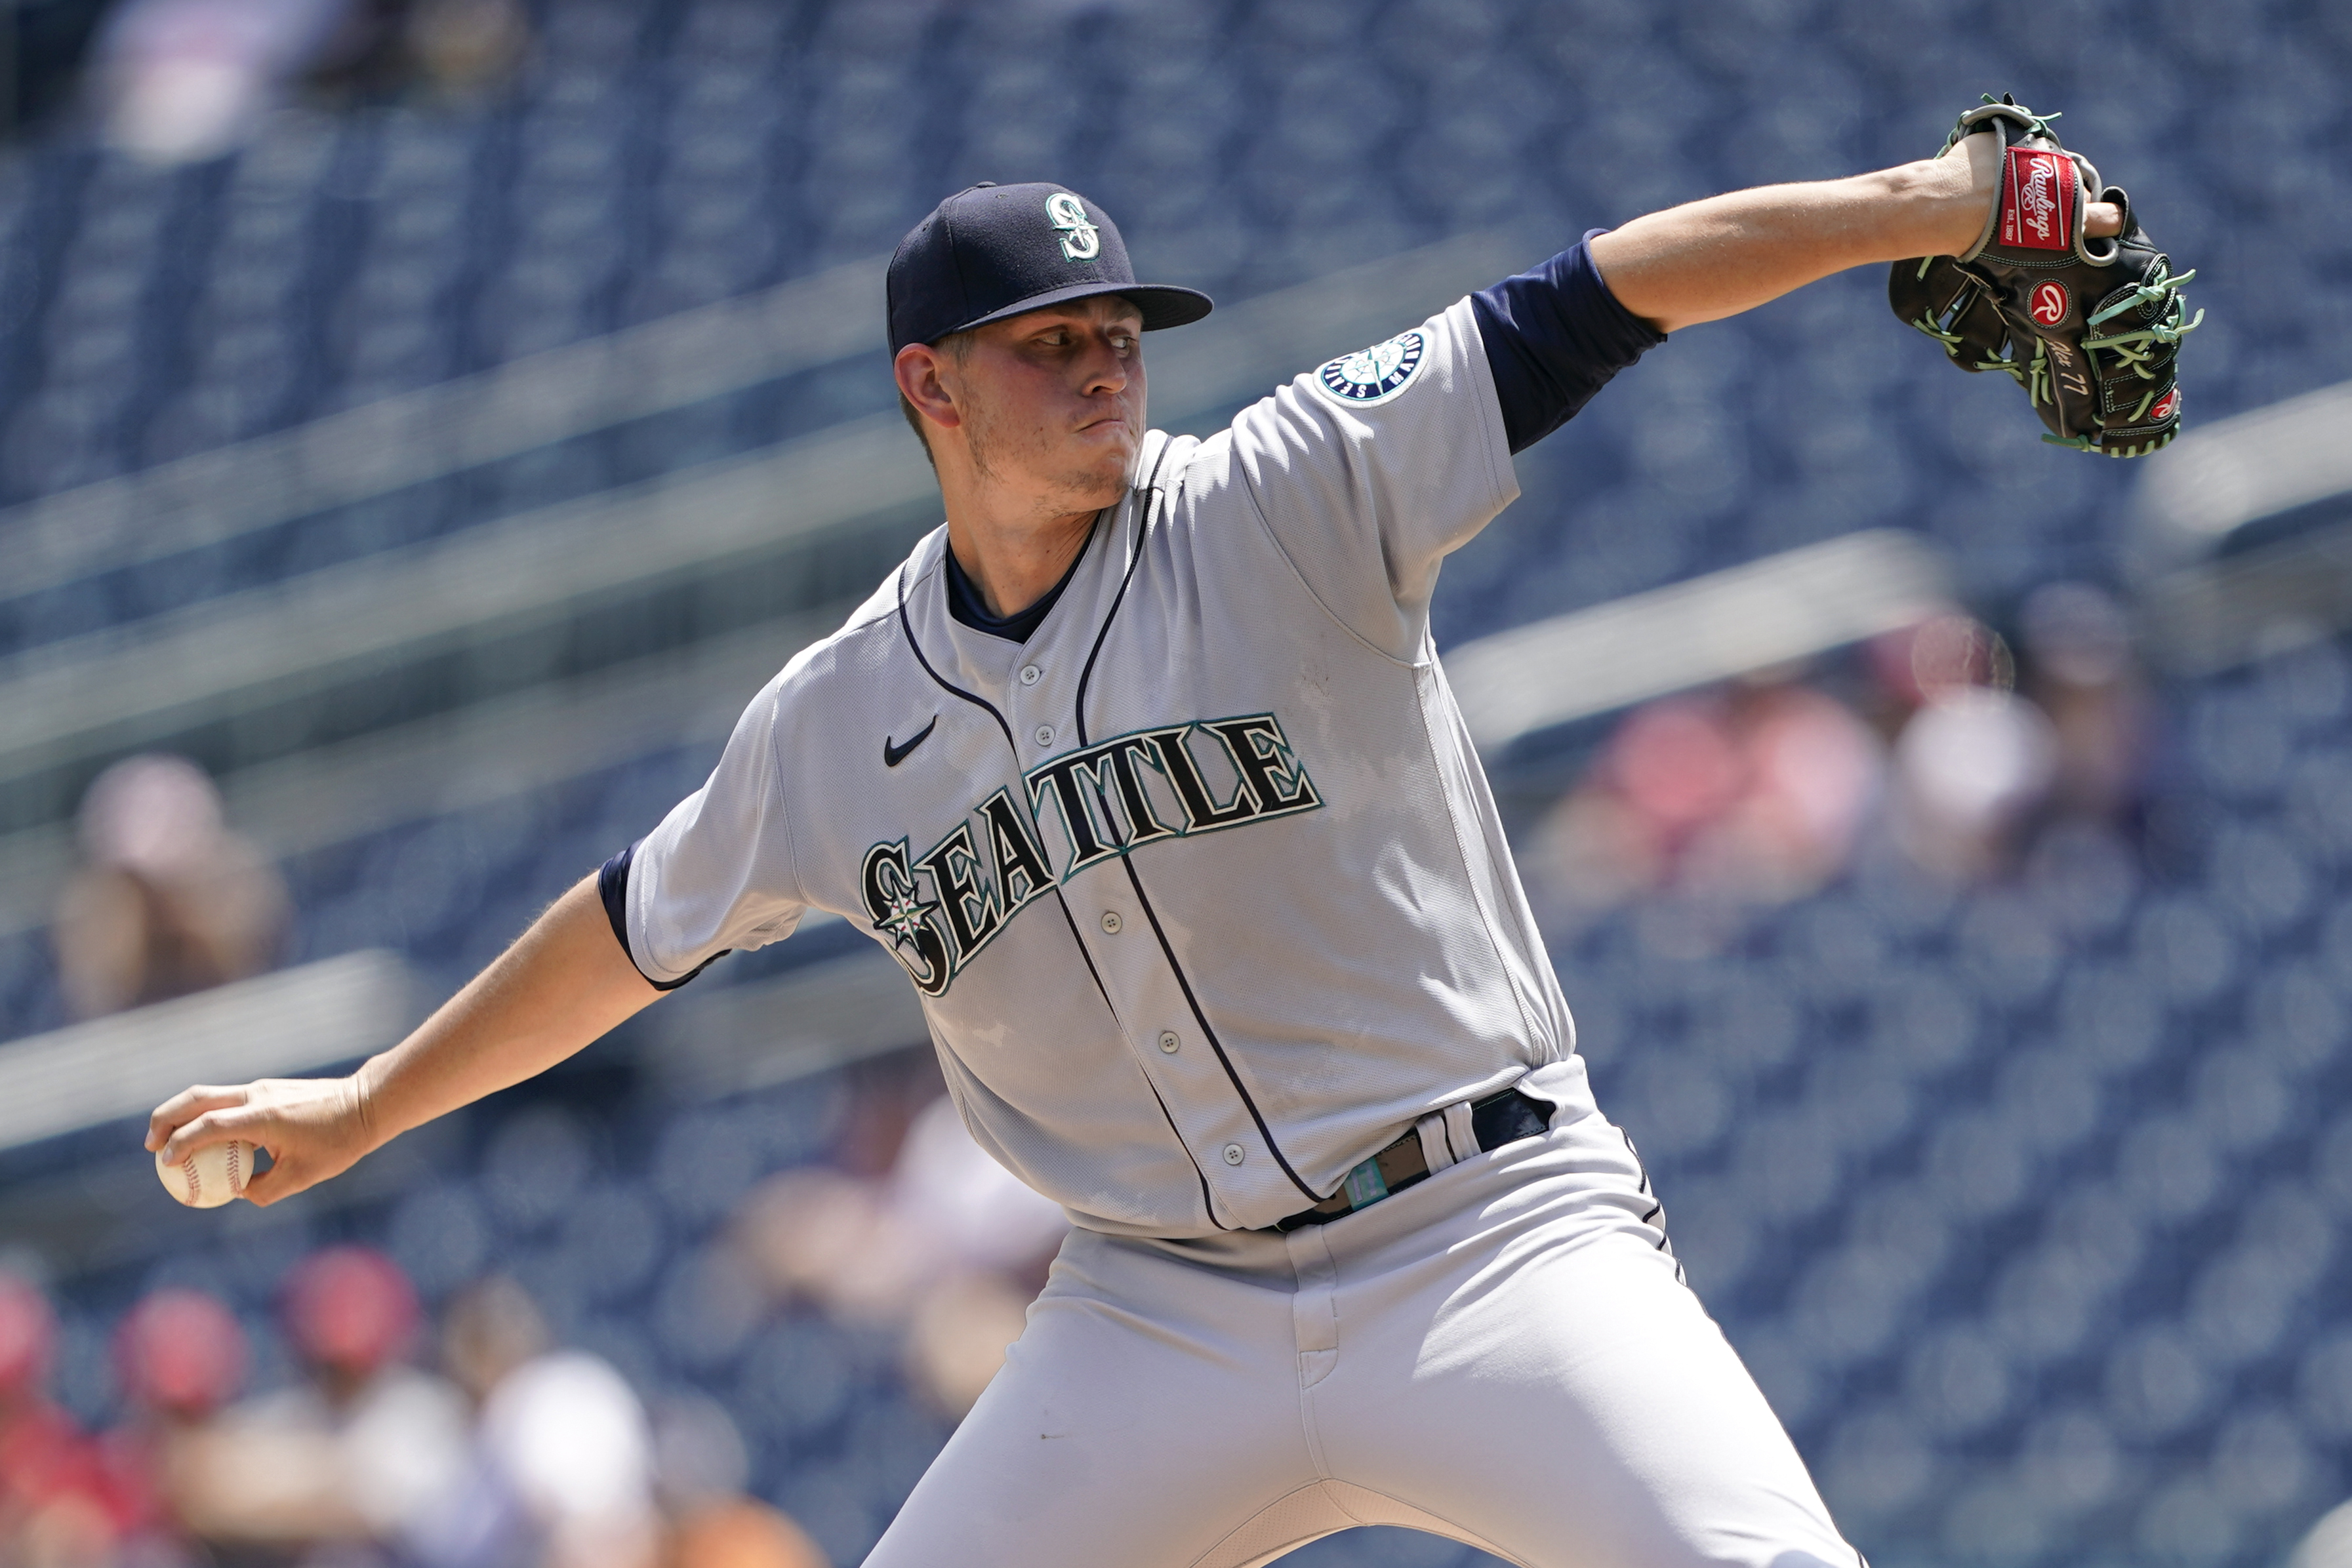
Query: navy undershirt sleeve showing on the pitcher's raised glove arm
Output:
[[1470, 228, 1665, 451]]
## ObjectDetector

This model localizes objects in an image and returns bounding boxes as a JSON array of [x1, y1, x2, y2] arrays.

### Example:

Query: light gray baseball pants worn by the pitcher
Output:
[[866, 1058, 1858, 1568]]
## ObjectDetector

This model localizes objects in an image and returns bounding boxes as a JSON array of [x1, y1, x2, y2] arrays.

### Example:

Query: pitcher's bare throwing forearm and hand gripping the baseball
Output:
[[146, 877, 661, 1203]]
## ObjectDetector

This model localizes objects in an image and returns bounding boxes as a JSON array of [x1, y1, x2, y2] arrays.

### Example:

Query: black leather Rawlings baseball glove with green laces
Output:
[[1886, 96, 2204, 458]]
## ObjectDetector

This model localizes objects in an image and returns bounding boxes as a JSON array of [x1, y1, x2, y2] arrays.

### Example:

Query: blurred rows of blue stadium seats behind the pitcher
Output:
[[0, 0, 2352, 1568]]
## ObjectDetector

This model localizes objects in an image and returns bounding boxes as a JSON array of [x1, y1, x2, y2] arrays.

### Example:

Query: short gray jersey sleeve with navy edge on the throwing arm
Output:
[[598, 677, 807, 990]]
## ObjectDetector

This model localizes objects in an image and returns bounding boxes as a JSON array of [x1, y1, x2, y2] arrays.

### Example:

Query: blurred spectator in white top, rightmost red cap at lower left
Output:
[[174, 1246, 466, 1561]]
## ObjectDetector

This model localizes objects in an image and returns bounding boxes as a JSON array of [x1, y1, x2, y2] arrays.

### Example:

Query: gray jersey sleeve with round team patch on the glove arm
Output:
[[1230, 298, 1520, 658]]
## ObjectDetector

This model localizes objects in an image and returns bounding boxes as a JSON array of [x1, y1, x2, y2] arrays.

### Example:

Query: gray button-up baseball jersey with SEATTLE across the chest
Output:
[[626, 301, 1573, 1237]]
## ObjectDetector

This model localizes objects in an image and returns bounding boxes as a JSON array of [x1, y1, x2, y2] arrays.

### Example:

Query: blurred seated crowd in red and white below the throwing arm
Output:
[[0, 1091, 1063, 1568]]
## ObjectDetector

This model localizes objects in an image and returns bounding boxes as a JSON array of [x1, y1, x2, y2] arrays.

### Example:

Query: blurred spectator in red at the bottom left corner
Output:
[[0, 1274, 120, 1568]]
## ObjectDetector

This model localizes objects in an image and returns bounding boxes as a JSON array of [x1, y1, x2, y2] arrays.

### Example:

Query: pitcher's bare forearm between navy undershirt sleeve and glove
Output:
[[1592, 134, 2124, 331]]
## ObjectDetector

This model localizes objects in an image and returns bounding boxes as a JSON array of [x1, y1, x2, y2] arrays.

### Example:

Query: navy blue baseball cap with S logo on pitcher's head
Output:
[[889, 184, 1211, 355]]
